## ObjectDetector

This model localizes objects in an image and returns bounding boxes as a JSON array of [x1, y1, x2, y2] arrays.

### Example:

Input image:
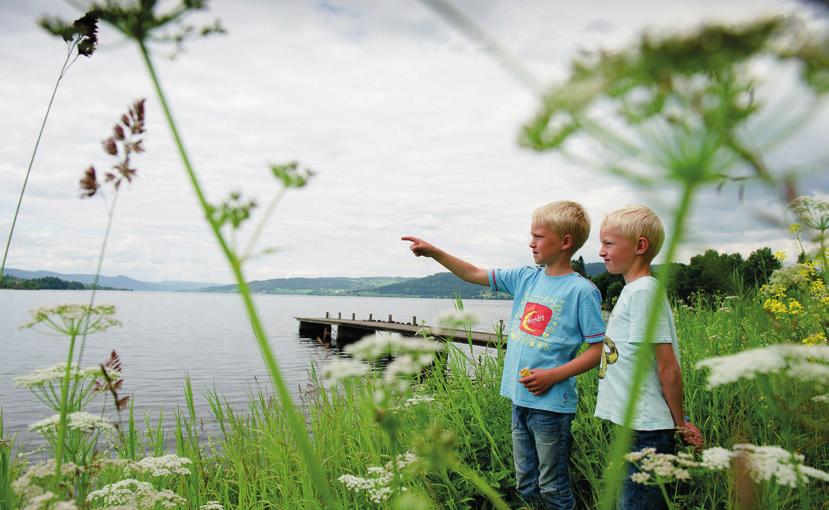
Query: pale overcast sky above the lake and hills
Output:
[[0, 0, 829, 283]]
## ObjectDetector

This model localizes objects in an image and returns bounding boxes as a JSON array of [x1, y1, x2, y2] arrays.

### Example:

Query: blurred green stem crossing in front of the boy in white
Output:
[[600, 182, 696, 510]]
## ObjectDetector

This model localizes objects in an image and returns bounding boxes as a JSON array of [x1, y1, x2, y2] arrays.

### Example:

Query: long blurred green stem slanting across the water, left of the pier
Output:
[[138, 41, 340, 508]]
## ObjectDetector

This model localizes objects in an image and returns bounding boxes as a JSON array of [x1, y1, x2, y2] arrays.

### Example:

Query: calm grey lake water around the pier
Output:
[[0, 290, 511, 442]]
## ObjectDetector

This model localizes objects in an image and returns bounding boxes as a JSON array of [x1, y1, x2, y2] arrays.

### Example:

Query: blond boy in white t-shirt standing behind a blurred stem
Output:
[[596, 206, 703, 510]]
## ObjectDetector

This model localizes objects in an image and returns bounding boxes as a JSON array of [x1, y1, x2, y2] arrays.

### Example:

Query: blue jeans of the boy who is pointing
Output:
[[512, 405, 575, 510]]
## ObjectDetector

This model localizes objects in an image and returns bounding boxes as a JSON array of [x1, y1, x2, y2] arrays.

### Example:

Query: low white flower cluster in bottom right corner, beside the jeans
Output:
[[625, 444, 829, 487]]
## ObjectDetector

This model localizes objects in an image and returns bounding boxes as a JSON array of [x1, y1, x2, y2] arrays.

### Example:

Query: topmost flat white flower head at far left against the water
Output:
[[20, 304, 121, 336]]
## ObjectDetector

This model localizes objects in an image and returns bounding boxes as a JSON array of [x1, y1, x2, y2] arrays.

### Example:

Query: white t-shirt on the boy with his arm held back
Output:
[[596, 276, 679, 430]]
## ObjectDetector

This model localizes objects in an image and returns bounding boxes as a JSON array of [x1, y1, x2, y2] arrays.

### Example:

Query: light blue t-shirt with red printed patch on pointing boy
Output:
[[489, 266, 605, 413]]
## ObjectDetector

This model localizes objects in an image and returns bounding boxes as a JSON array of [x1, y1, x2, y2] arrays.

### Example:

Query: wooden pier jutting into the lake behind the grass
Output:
[[294, 313, 503, 348]]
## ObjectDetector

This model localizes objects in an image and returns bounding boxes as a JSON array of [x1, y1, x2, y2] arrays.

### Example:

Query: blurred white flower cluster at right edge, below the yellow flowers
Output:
[[697, 344, 829, 388]]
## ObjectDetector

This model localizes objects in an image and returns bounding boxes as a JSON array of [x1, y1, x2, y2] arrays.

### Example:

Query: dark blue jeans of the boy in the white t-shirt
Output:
[[619, 429, 676, 510]]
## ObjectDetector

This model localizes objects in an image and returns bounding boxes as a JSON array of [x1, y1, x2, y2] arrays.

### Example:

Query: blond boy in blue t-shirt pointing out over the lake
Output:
[[402, 201, 605, 510]]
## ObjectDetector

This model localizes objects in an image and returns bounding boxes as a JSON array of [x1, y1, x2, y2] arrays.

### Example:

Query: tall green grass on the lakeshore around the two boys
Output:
[[6, 288, 829, 509]]
